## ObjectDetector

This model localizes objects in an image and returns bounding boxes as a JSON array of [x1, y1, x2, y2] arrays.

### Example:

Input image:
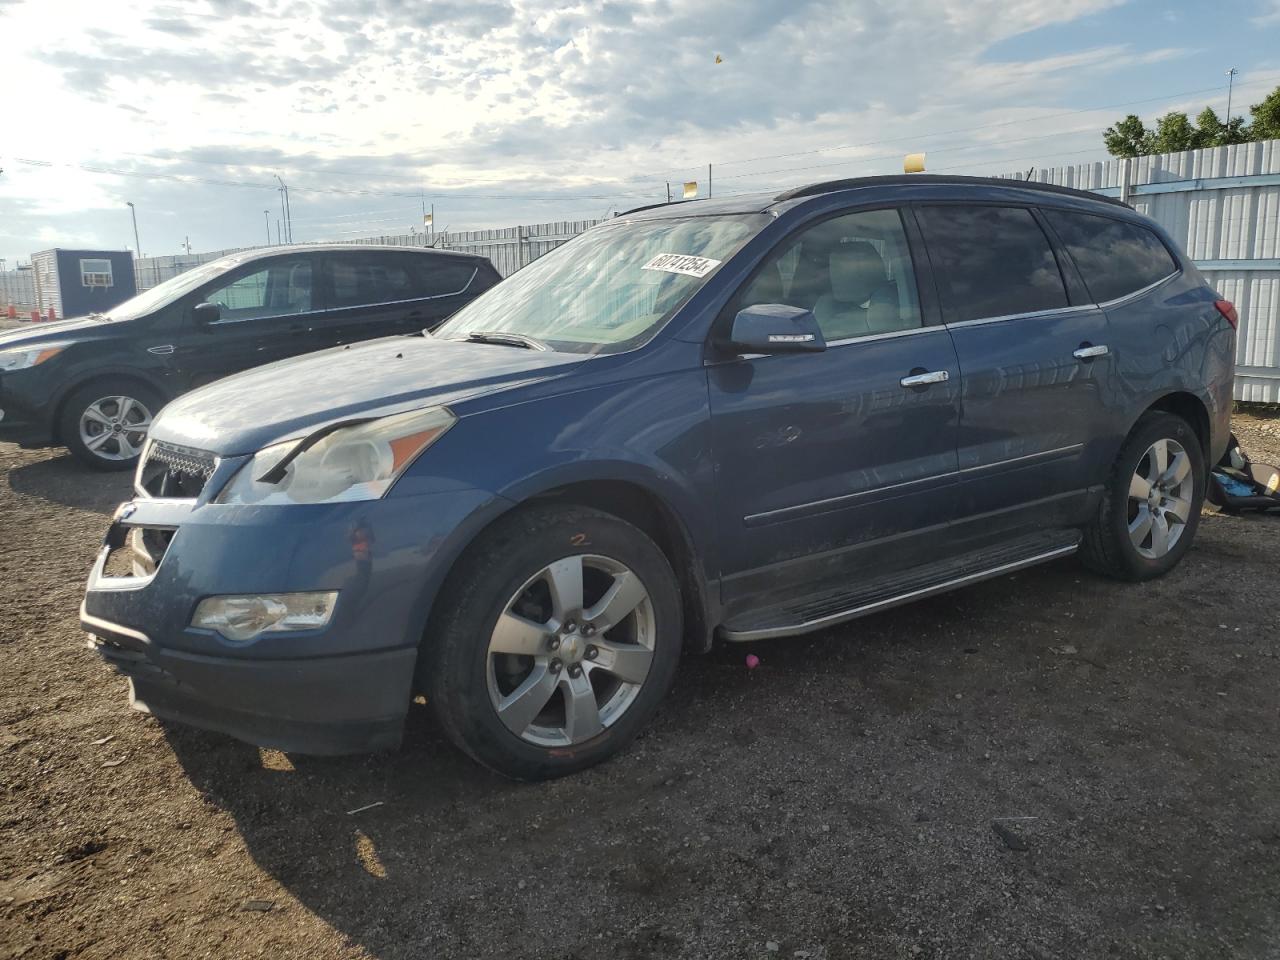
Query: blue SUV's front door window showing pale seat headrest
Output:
[[737, 210, 923, 343]]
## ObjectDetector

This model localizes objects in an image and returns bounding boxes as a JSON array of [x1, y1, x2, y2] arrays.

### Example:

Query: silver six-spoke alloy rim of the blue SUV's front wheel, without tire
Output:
[[486, 554, 655, 746]]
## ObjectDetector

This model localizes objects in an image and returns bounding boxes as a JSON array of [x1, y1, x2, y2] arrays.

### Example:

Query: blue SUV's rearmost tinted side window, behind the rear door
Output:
[[1044, 210, 1178, 303]]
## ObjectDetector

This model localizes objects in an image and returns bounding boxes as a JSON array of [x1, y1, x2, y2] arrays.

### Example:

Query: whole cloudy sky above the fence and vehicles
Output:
[[0, 0, 1280, 269]]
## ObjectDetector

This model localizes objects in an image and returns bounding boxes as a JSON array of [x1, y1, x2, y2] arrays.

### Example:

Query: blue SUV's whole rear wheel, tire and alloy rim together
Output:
[[1080, 411, 1207, 581]]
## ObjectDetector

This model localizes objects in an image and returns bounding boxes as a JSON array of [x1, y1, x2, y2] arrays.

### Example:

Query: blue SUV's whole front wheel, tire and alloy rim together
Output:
[[420, 507, 684, 781]]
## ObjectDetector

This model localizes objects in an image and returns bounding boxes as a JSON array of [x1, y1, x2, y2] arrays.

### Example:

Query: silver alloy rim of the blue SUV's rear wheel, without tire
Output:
[[1128, 439, 1196, 559]]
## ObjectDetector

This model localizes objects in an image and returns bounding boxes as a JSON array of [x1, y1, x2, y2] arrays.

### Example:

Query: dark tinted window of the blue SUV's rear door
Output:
[[919, 204, 1068, 324]]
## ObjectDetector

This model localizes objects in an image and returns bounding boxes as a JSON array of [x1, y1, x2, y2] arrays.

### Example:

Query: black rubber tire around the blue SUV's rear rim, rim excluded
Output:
[[1106, 413, 1208, 580]]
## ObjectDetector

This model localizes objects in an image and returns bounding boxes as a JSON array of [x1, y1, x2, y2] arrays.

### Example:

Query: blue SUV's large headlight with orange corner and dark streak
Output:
[[215, 407, 457, 503]]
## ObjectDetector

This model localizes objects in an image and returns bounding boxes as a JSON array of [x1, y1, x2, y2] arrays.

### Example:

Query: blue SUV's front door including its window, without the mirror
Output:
[[708, 210, 960, 614]]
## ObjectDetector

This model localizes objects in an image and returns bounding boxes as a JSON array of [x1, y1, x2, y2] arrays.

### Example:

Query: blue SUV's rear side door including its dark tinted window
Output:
[[916, 204, 1111, 535]]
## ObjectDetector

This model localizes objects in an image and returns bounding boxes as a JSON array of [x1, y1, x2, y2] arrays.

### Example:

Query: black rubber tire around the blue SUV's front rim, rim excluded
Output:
[[424, 507, 684, 780]]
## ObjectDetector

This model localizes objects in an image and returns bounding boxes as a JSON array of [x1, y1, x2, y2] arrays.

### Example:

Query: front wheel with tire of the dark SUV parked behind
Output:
[[58, 380, 164, 470]]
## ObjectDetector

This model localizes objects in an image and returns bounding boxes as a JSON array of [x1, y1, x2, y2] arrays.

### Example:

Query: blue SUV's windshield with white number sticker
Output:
[[435, 214, 769, 353]]
